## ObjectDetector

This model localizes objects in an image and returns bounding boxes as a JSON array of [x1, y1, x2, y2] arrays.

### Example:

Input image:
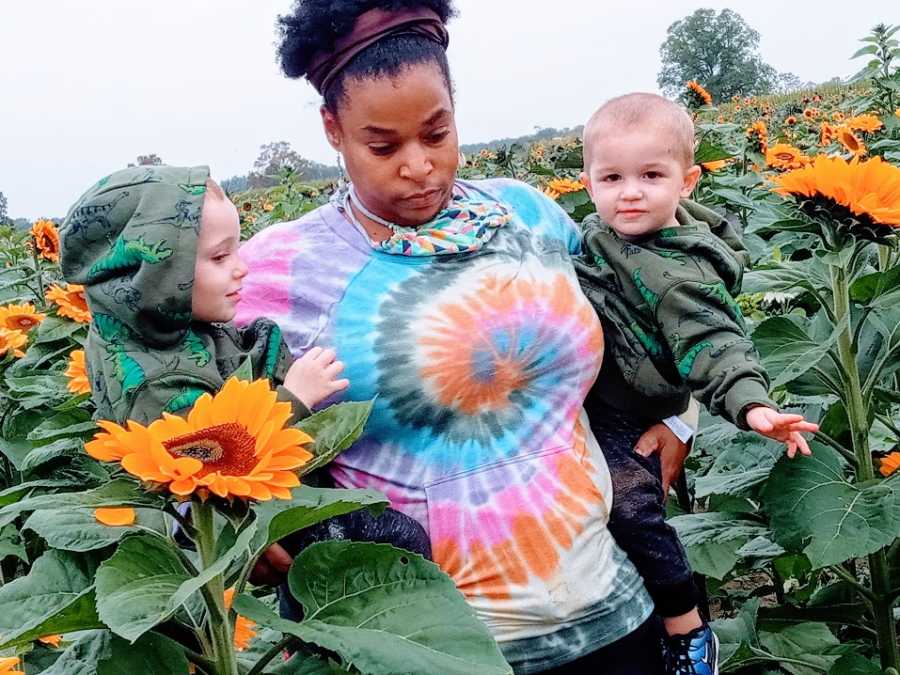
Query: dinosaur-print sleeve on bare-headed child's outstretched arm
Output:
[[656, 280, 778, 429]]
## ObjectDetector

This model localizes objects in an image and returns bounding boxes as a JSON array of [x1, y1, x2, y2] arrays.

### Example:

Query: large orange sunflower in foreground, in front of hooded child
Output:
[[84, 377, 312, 500]]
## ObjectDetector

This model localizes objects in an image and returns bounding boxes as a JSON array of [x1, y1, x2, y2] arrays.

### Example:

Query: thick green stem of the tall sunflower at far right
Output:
[[831, 265, 900, 669]]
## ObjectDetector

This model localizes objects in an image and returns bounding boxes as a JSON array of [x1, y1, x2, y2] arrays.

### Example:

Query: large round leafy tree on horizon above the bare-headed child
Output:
[[656, 9, 777, 103]]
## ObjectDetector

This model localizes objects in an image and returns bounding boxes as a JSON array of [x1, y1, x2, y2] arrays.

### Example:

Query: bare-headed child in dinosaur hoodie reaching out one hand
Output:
[[575, 94, 818, 675]]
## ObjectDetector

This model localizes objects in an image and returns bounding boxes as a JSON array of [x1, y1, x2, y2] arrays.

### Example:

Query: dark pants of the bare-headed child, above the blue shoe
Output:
[[589, 406, 699, 617]]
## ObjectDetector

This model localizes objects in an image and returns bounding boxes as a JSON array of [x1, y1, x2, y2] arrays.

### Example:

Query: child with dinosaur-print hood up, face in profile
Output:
[[60, 166, 431, 604]]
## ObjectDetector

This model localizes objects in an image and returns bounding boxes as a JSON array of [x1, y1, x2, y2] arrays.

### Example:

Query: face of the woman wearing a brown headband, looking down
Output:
[[322, 64, 459, 225]]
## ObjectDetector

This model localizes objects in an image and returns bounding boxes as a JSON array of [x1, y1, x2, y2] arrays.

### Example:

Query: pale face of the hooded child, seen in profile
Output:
[[191, 192, 247, 322]]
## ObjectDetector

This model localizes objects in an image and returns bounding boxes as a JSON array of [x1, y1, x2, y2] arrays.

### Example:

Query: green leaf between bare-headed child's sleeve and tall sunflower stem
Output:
[[753, 316, 837, 389]]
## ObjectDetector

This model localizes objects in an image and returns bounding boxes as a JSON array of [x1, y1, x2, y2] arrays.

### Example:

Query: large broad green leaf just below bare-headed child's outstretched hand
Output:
[[763, 442, 900, 569]]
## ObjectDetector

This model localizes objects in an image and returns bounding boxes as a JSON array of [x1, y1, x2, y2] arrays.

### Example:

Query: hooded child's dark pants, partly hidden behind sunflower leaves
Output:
[[278, 509, 431, 621]]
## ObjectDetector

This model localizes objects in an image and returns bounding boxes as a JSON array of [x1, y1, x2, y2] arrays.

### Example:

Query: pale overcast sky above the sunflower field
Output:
[[0, 0, 900, 219]]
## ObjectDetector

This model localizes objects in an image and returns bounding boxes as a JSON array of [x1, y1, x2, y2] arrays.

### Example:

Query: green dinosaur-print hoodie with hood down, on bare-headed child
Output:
[[575, 201, 777, 429]]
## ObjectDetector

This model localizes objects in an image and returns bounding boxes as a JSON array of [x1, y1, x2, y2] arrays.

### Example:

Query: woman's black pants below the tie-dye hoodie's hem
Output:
[[542, 617, 665, 675]]
